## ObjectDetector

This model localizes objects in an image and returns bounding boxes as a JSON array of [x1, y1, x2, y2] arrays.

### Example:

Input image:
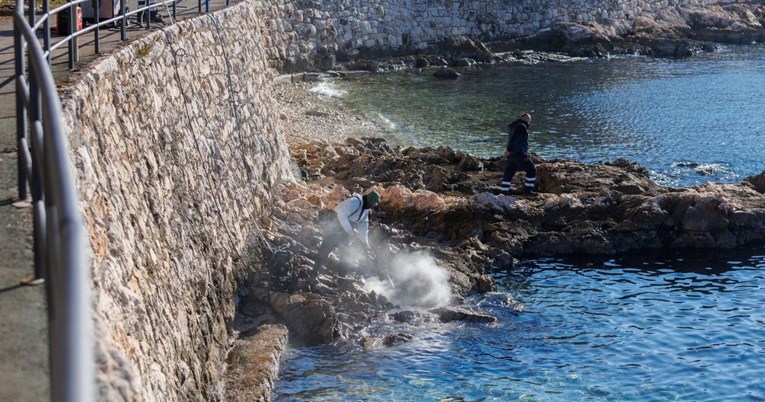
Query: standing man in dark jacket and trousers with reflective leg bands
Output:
[[502, 113, 537, 195]]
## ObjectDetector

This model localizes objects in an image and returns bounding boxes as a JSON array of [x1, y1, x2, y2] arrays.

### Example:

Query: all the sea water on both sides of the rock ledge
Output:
[[273, 45, 765, 401]]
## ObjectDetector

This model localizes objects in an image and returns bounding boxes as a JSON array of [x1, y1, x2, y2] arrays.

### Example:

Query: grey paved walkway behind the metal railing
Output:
[[0, 0, 225, 402]]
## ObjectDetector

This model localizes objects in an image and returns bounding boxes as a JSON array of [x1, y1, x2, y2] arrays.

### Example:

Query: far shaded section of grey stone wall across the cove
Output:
[[259, 0, 761, 71]]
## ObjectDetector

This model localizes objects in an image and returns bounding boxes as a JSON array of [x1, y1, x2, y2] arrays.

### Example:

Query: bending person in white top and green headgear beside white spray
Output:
[[316, 191, 380, 265]]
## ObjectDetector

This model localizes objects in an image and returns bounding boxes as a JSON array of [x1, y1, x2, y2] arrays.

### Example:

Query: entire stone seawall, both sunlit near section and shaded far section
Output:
[[58, 0, 760, 401]]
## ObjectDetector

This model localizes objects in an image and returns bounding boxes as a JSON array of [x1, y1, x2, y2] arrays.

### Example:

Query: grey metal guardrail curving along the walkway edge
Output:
[[13, 0, 230, 402]]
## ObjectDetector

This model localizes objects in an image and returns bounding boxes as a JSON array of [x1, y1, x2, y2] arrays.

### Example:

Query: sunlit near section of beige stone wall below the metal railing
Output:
[[59, 3, 291, 401]]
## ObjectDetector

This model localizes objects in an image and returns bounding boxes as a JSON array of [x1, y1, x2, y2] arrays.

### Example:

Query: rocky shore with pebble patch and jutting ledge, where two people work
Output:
[[227, 64, 765, 400]]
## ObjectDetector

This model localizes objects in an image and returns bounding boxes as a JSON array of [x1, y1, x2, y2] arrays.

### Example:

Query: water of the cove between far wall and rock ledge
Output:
[[324, 45, 765, 186]]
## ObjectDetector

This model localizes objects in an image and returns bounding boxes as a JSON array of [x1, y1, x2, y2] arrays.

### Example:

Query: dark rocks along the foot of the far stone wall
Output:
[[274, 3, 765, 72]]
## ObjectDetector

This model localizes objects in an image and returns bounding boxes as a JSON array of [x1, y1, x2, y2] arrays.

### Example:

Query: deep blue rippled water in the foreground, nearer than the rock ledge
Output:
[[274, 249, 765, 401]]
